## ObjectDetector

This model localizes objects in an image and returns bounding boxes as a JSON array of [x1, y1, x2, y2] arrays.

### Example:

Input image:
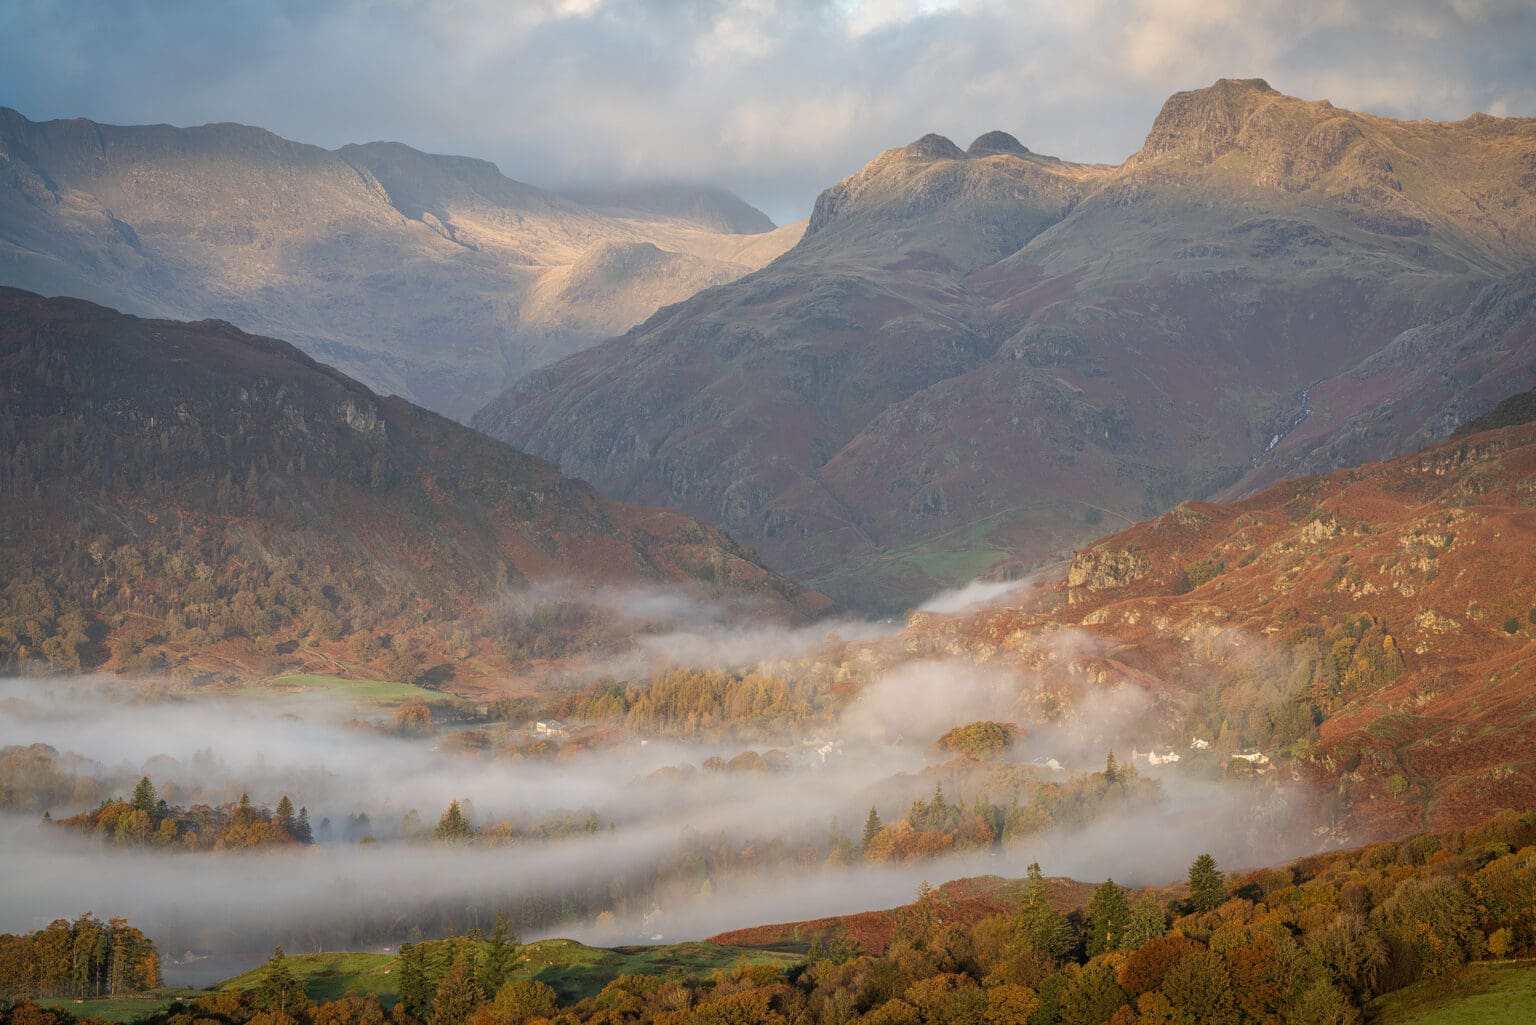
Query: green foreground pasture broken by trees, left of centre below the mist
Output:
[[38, 939, 799, 1022]]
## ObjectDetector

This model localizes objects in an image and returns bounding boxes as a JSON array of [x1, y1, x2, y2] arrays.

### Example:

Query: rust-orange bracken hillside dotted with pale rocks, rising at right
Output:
[[902, 400, 1536, 839]]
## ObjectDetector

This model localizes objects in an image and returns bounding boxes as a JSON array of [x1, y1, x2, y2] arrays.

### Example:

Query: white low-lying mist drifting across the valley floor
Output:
[[0, 577, 1318, 984]]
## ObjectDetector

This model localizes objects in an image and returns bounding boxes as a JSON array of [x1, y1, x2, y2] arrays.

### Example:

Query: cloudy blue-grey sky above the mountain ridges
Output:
[[0, 0, 1536, 223]]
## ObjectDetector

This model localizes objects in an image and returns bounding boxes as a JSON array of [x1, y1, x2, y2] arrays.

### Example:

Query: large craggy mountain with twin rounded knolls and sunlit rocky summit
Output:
[[475, 80, 1536, 607]]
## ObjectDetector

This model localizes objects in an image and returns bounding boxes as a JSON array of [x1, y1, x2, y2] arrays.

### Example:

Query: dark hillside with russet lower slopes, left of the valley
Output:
[[0, 289, 826, 682]]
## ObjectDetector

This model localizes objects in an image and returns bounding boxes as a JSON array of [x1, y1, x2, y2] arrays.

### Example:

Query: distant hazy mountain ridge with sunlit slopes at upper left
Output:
[[0, 109, 799, 416]]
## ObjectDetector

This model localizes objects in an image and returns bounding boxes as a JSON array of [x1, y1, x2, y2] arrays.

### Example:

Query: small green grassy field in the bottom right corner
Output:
[[1366, 960, 1536, 1025]]
